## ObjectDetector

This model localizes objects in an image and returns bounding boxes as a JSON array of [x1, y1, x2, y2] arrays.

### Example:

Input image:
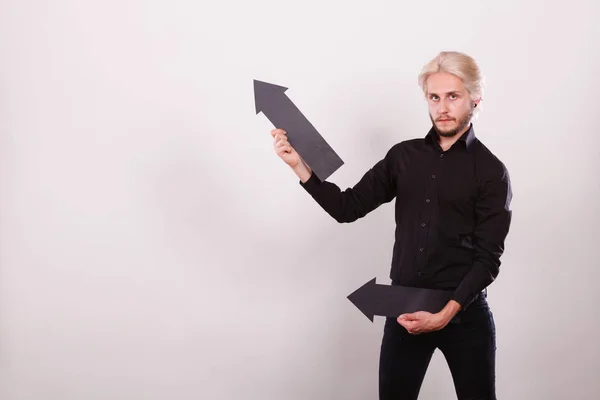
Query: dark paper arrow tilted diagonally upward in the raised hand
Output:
[[254, 80, 344, 181]]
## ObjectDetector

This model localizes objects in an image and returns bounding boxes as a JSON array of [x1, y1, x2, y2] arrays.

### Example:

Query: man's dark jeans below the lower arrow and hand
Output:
[[379, 293, 496, 400]]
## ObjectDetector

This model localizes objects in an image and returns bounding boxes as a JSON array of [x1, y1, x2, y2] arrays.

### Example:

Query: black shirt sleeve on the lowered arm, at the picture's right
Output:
[[452, 165, 512, 309]]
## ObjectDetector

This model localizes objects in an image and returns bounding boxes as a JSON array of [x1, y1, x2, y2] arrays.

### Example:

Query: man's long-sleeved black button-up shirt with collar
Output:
[[300, 125, 512, 308]]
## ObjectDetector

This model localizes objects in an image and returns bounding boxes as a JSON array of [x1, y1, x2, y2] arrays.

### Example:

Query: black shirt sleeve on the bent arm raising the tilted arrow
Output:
[[300, 147, 396, 223]]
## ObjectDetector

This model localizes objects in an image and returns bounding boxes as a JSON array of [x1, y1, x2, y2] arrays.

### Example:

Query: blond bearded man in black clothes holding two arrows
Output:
[[272, 52, 512, 400]]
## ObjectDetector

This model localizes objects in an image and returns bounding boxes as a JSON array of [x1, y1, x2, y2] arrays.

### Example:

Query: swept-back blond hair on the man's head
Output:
[[419, 51, 484, 104]]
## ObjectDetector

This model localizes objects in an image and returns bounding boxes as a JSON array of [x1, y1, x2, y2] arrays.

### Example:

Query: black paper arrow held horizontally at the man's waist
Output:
[[348, 278, 452, 322]]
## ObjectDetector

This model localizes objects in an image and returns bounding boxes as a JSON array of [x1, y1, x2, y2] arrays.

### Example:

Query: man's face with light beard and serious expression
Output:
[[427, 72, 474, 137]]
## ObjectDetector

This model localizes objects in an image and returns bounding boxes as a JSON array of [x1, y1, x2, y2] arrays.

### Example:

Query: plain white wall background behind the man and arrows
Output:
[[0, 0, 600, 400]]
